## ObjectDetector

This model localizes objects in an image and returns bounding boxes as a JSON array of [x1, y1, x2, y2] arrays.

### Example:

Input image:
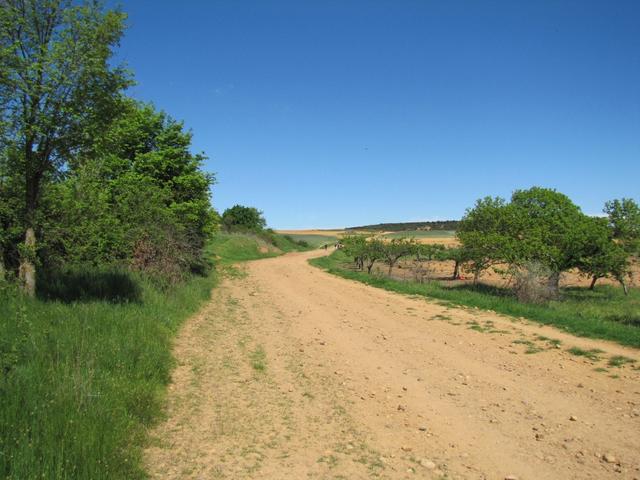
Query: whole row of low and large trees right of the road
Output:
[[342, 187, 640, 298]]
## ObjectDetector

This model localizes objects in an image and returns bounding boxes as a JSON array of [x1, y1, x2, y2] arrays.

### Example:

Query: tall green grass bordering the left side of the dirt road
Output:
[[0, 234, 300, 480]]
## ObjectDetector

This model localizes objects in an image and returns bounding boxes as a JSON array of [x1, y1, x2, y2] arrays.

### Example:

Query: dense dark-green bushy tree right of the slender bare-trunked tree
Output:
[[42, 99, 217, 282]]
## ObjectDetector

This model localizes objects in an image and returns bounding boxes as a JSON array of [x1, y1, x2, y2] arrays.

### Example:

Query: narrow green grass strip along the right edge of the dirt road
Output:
[[310, 251, 640, 348]]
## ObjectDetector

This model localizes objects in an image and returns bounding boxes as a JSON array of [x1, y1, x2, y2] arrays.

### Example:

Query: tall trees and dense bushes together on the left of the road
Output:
[[0, 0, 219, 296]]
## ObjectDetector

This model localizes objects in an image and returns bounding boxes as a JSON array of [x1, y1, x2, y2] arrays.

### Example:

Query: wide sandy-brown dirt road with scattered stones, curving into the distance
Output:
[[146, 252, 640, 480]]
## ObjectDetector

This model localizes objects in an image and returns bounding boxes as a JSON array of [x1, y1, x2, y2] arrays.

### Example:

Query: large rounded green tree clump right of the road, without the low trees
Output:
[[457, 187, 635, 294]]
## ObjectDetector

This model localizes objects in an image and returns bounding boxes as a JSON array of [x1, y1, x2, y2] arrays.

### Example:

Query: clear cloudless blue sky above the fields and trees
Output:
[[118, 0, 640, 228]]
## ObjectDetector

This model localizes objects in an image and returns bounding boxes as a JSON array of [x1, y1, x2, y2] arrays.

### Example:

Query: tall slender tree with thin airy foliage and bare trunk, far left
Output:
[[0, 0, 130, 296]]
